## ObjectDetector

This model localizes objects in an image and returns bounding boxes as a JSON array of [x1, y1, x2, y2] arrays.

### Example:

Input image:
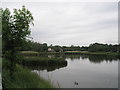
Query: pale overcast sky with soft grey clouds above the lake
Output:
[[2, 0, 118, 46]]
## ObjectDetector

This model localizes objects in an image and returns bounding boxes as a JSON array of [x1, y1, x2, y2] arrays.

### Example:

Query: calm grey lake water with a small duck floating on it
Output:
[[33, 55, 118, 88]]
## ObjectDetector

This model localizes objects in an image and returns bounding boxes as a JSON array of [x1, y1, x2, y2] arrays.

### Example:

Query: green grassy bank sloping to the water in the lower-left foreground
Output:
[[3, 62, 53, 88]]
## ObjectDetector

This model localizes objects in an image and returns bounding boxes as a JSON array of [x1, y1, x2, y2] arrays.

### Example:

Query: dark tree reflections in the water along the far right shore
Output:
[[66, 55, 120, 63]]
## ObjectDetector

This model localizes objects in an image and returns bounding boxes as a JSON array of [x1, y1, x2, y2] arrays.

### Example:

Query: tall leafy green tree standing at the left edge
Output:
[[2, 6, 34, 69]]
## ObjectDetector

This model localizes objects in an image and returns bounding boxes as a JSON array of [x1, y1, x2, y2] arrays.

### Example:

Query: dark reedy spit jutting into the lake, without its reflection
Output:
[[21, 56, 67, 67]]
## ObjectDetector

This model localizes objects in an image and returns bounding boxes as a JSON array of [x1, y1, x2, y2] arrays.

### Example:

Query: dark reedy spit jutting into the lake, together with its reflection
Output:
[[22, 56, 67, 71]]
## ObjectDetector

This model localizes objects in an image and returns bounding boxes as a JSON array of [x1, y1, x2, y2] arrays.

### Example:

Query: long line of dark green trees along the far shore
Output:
[[21, 40, 120, 52]]
